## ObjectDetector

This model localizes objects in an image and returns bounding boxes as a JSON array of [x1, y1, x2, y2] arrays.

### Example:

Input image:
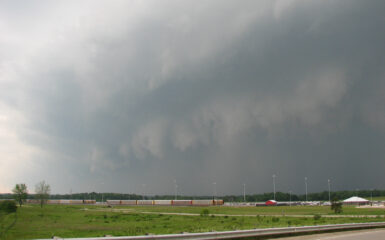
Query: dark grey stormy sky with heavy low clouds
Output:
[[0, 0, 385, 195]]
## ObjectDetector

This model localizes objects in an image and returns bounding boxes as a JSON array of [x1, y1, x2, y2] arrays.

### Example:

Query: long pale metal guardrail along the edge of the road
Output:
[[42, 222, 385, 240]]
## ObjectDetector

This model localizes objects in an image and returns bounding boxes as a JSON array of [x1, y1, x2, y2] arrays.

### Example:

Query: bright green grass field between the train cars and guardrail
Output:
[[5, 205, 384, 239]]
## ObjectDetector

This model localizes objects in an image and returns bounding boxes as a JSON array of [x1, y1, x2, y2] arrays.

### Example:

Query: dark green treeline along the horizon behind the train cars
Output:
[[0, 189, 385, 202]]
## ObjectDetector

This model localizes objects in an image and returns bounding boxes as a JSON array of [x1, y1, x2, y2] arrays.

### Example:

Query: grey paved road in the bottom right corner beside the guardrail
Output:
[[268, 229, 385, 240]]
